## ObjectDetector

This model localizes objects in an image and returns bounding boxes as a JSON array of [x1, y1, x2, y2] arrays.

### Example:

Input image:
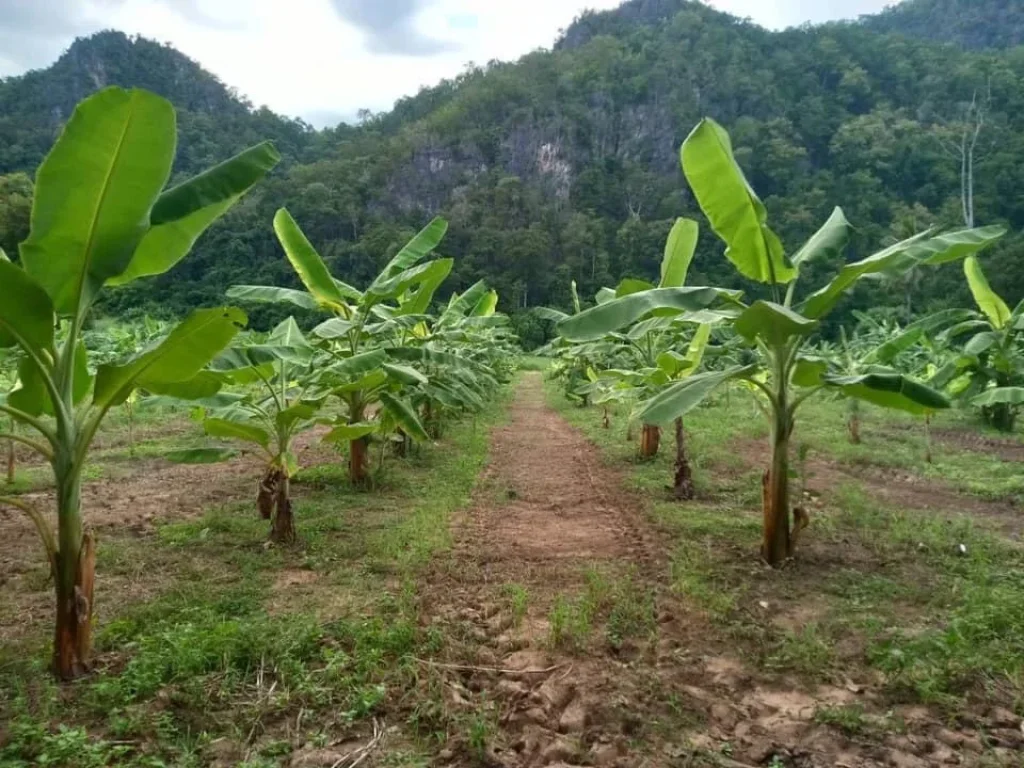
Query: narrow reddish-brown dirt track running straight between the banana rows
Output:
[[424, 373, 667, 768]]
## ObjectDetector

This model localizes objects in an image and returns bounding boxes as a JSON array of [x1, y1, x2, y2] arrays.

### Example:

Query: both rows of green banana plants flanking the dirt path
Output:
[[0, 88, 1011, 679]]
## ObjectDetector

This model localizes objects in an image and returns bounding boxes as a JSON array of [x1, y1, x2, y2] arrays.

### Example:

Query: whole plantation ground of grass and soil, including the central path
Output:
[[0, 368, 1024, 768]]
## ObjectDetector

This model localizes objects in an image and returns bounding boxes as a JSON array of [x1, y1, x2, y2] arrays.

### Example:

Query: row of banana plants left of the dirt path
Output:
[[0, 88, 518, 679]]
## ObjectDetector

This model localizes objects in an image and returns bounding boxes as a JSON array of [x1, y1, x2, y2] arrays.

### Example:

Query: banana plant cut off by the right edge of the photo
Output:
[[937, 257, 1024, 432]]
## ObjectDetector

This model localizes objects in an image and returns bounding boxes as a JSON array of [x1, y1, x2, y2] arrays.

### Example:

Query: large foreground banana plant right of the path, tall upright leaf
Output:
[[558, 119, 1005, 566]]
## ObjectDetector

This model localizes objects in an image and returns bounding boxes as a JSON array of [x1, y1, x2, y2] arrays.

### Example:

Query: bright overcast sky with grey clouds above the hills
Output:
[[0, 0, 893, 126]]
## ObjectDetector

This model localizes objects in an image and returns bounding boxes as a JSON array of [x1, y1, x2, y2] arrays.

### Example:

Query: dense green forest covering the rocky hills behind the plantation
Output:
[[0, 0, 1024, 340]]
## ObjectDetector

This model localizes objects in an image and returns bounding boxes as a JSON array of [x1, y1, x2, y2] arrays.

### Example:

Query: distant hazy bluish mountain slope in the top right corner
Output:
[[864, 0, 1024, 50]]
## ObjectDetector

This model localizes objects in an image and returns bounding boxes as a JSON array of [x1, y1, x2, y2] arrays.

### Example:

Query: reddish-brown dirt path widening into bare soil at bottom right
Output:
[[423, 374, 1020, 768]]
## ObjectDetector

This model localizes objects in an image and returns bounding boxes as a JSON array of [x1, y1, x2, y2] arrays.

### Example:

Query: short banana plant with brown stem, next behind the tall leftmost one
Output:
[[171, 317, 325, 544]]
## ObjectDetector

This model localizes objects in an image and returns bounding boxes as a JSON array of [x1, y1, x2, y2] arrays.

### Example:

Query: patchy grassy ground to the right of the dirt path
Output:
[[548, 382, 1024, 765]]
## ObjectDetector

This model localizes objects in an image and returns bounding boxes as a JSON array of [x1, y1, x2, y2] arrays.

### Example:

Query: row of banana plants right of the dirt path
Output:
[[542, 120, 1011, 565]]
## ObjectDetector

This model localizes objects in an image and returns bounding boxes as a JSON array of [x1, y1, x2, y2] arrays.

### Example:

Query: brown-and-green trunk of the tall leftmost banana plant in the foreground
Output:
[[53, 468, 96, 680]]
